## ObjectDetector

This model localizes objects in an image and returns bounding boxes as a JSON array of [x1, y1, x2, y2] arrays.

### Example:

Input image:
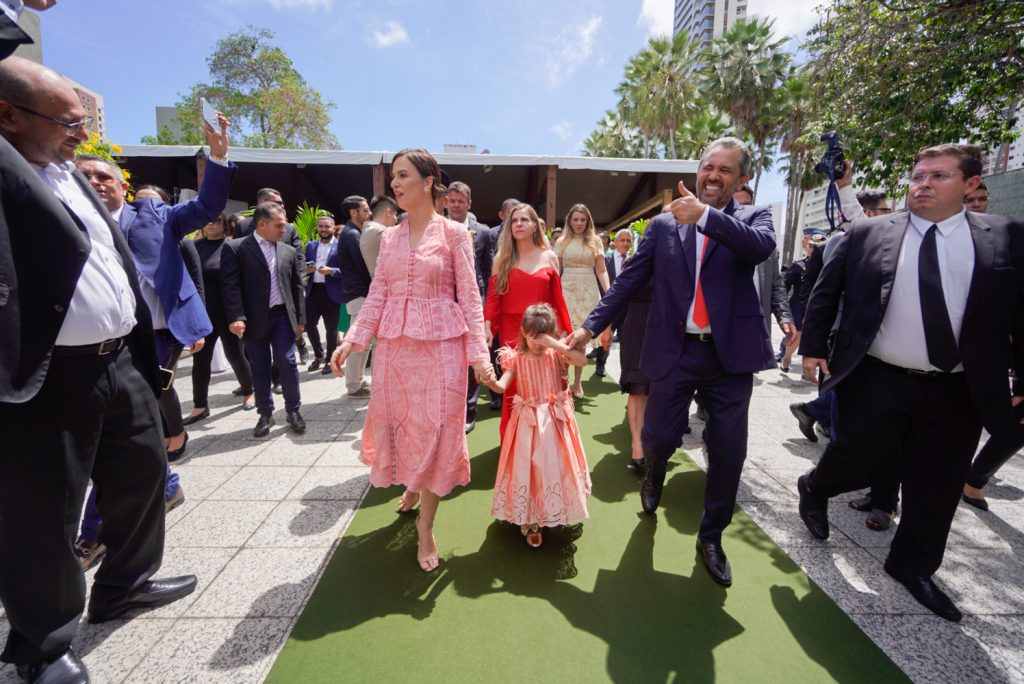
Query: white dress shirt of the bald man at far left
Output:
[[36, 162, 135, 346]]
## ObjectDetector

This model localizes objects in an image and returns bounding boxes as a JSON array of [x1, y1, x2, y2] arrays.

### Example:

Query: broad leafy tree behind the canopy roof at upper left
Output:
[[142, 27, 339, 149]]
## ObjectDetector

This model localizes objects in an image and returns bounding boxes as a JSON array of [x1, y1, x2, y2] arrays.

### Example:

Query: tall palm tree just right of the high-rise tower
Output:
[[701, 19, 792, 193]]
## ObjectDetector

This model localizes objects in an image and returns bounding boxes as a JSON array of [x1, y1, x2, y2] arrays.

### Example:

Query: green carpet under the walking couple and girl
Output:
[[267, 372, 907, 683]]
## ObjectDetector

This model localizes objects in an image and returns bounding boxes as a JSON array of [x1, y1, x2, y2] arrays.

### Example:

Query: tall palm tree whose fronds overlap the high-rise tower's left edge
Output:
[[615, 32, 697, 159]]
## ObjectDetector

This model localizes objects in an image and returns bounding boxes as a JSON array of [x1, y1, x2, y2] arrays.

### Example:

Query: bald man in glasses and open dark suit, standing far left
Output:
[[0, 57, 196, 682]]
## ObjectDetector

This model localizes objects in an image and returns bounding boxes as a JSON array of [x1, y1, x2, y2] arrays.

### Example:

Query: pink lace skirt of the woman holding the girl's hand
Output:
[[360, 337, 469, 497]]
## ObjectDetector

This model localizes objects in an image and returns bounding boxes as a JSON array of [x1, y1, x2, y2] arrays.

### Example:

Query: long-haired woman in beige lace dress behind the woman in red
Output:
[[555, 204, 608, 397]]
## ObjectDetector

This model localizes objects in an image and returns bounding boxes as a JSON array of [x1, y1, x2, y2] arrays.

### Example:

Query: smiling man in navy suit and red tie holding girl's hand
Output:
[[569, 137, 775, 587]]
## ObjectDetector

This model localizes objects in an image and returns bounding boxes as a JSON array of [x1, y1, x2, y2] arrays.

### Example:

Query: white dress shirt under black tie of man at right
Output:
[[867, 211, 974, 373]]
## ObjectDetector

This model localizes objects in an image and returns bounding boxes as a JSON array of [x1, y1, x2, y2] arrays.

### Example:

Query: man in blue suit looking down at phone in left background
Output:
[[305, 216, 342, 375]]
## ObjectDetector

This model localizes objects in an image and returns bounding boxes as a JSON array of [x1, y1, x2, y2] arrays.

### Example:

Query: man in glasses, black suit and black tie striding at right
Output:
[[798, 144, 1024, 622]]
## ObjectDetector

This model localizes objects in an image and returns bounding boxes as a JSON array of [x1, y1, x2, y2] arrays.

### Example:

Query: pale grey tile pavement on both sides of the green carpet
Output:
[[0, 337, 1024, 684]]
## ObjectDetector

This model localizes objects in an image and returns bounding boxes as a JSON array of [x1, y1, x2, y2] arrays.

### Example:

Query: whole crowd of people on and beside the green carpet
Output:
[[0, 7, 1024, 682]]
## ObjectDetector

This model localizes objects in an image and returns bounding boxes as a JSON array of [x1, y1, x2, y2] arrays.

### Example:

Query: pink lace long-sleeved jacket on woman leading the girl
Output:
[[345, 218, 489, 364]]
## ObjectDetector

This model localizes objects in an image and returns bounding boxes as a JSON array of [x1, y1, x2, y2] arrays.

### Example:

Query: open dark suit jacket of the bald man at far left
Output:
[[0, 138, 160, 403]]
